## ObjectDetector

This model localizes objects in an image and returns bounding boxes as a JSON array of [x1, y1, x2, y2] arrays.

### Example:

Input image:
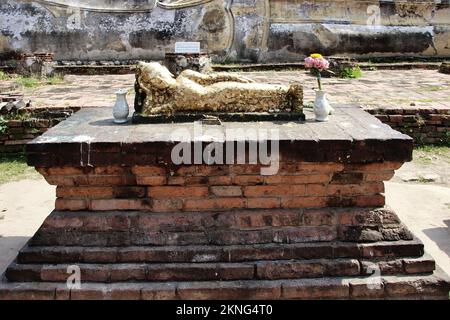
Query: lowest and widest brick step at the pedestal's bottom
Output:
[[0, 272, 450, 300]]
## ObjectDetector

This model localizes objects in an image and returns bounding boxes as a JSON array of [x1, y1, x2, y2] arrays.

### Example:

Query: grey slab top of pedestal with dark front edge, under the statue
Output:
[[27, 106, 413, 167]]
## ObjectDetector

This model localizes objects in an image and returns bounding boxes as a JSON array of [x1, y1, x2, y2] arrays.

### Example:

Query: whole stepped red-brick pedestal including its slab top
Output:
[[0, 108, 449, 299]]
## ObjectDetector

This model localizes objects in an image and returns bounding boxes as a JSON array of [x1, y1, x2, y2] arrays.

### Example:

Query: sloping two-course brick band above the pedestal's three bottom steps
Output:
[[30, 208, 412, 247]]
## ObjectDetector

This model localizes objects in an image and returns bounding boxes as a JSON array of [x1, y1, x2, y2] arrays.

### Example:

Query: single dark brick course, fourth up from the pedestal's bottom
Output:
[[29, 226, 413, 247]]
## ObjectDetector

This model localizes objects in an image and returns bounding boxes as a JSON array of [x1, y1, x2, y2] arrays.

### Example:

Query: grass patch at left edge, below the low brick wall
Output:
[[0, 153, 39, 184]]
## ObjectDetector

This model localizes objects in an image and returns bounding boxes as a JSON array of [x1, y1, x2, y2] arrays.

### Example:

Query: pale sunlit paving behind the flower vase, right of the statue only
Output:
[[246, 69, 450, 109]]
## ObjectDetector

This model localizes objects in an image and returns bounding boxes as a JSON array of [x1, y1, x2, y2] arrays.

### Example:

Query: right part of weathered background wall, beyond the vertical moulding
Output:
[[267, 0, 450, 60]]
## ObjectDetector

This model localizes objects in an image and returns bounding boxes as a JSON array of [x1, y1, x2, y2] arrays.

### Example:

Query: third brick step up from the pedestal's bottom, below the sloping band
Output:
[[17, 239, 424, 264]]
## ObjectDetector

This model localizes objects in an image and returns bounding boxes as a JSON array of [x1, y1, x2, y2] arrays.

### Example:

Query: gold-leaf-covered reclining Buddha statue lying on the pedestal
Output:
[[135, 62, 303, 116]]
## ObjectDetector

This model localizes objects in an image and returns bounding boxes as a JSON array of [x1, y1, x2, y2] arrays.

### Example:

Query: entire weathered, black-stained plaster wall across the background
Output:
[[0, 0, 450, 62]]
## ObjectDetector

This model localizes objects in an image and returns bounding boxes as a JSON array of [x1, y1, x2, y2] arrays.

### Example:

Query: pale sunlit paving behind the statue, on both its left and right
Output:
[[7, 69, 450, 109]]
